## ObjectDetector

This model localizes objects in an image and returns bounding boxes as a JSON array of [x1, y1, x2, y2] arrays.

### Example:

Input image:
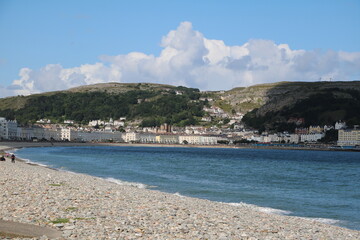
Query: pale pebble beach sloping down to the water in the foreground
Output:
[[0, 143, 360, 240]]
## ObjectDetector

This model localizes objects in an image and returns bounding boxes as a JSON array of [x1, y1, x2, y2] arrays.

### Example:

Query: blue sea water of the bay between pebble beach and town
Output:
[[16, 146, 360, 230]]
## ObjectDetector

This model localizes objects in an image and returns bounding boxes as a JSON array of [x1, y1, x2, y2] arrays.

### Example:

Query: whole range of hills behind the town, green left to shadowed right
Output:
[[0, 81, 360, 131]]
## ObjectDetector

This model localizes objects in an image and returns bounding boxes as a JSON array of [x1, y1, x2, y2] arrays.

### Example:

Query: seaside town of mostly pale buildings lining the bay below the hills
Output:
[[0, 115, 360, 148]]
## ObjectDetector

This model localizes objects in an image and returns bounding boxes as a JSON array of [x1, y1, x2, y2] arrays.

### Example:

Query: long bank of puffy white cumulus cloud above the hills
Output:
[[4, 22, 360, 95]]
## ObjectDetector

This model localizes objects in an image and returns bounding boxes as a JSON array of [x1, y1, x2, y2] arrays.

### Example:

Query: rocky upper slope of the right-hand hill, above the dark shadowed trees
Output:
[[217, 81, 360, 116]]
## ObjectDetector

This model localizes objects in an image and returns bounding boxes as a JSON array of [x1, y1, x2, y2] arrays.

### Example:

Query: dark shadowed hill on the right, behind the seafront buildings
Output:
[[238, 82, 360, 131]]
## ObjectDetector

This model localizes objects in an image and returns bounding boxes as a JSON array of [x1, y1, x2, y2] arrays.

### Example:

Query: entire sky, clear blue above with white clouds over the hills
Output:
[[0, 0, 360, 97]]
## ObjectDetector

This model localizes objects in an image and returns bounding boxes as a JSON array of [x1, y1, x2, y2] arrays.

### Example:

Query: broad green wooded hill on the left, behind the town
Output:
[[0, 84, 203, 126]]
